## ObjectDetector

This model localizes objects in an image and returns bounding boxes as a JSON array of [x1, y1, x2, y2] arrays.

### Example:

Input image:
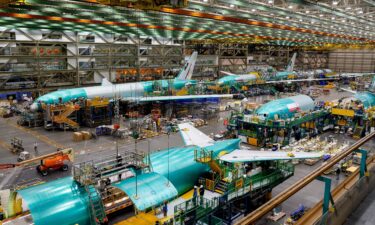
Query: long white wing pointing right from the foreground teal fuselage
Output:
[[220, 150, 322, 163]]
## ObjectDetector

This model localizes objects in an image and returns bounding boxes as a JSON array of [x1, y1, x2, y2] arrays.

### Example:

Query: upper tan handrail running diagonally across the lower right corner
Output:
[[236, 132, 375, 225]]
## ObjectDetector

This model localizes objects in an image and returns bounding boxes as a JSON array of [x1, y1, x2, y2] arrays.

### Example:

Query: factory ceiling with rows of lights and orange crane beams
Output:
[[0, 0, 375, 46]]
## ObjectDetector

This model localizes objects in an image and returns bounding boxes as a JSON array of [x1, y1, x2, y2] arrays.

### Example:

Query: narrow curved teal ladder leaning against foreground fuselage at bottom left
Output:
[[85, 185, 107, 225]]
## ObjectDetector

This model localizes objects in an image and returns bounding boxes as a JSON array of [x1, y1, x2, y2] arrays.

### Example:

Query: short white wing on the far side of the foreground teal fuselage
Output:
[[178, 123, 215, 148]]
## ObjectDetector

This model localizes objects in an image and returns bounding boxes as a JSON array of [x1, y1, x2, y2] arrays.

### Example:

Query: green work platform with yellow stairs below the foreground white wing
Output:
[[174, 149, 294, 225]]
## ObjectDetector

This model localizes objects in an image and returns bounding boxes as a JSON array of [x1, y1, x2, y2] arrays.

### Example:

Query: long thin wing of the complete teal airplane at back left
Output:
[[122, 94, 233, 102]]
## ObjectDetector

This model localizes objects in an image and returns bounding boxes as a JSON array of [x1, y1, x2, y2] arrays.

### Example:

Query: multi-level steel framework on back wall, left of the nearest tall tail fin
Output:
[[0, 28, 184, 94]]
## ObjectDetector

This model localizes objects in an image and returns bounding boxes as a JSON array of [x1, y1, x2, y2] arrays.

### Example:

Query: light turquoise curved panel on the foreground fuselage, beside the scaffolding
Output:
[[113, 173, 178, 211]]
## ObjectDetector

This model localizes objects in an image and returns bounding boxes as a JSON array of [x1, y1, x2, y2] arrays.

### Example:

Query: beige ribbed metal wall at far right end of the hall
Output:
[[328, 49, 375, 73]]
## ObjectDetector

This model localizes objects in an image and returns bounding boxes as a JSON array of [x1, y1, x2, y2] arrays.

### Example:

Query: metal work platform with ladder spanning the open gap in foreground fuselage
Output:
[[73, 152, 151, 224]]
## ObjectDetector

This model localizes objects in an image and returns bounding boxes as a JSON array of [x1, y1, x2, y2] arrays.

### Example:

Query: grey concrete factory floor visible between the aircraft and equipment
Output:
[[0, 88, 375, 224]]
